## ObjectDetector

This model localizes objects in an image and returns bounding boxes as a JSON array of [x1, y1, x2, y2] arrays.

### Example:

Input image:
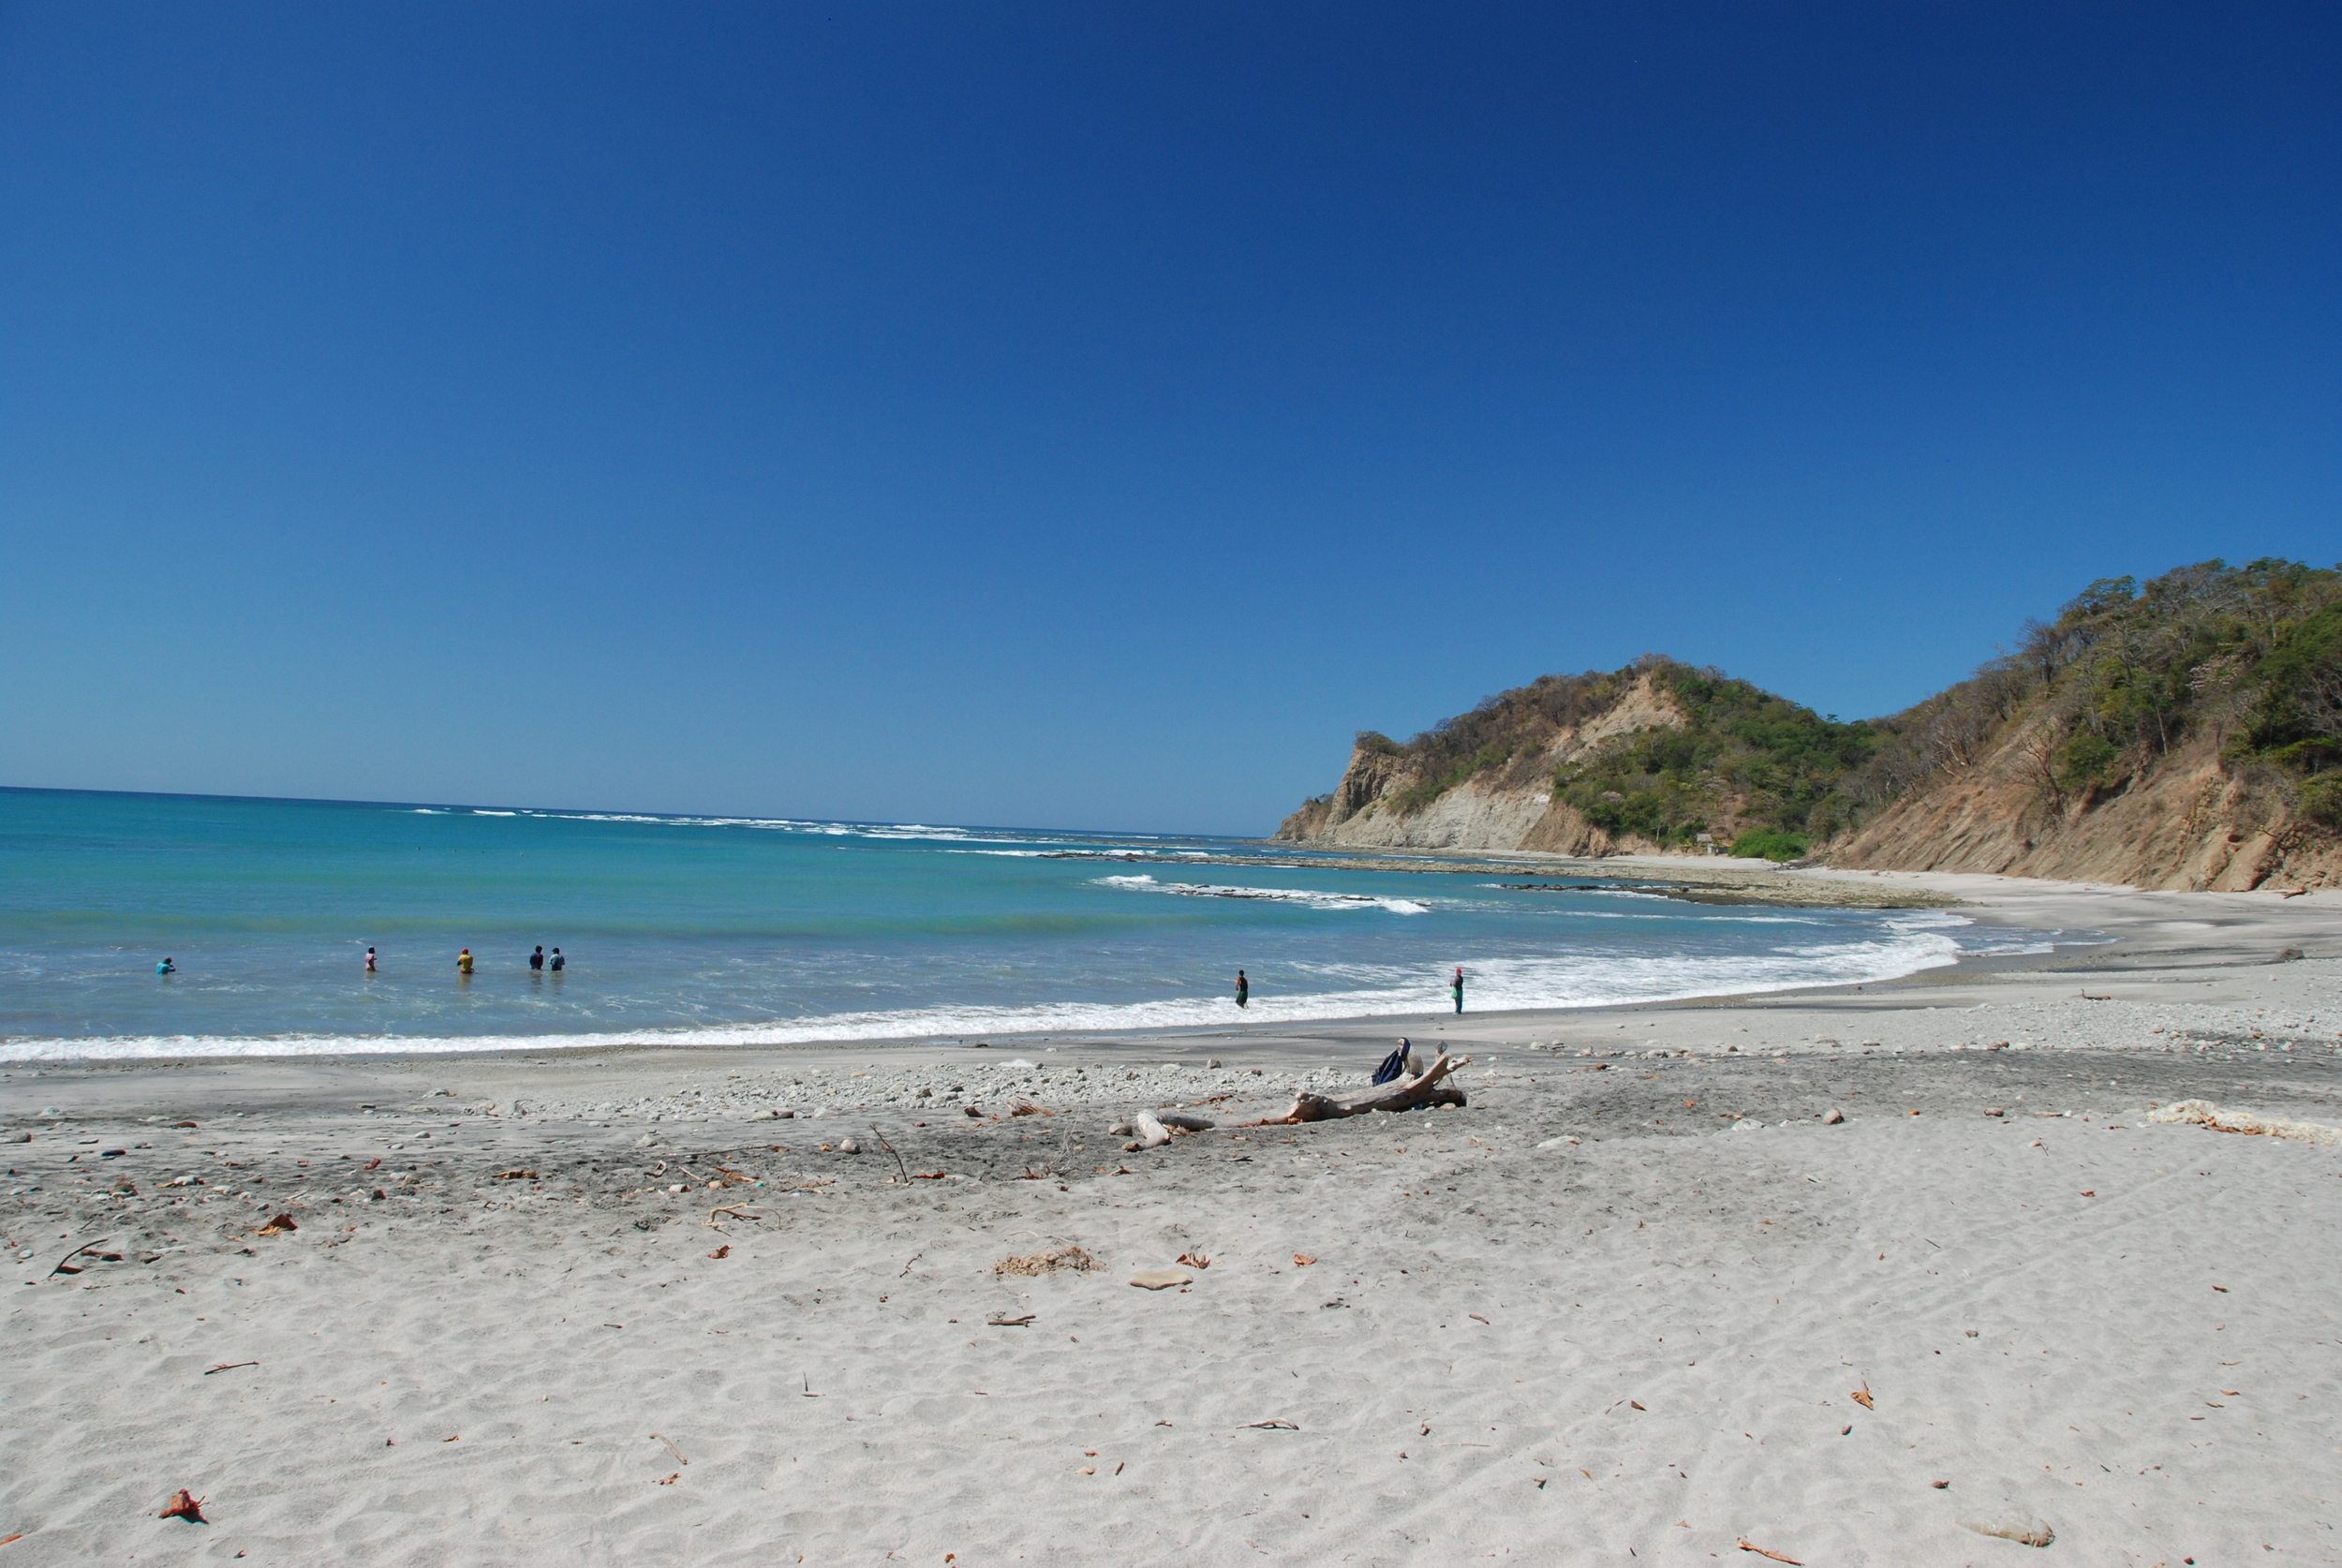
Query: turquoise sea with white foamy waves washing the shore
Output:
[[0, 789, 2054, 1062]]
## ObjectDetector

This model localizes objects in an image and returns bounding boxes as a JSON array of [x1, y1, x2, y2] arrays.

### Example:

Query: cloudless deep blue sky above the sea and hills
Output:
[[0, 0, 2342, 833]]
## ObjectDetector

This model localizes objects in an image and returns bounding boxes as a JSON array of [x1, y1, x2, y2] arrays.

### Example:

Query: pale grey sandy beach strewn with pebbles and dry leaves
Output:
[[0, 861, 2342, 1566]]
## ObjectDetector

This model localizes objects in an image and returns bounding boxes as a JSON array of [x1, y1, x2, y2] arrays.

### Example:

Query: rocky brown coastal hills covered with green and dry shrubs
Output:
[[1274, 562, 2342, 889]]
